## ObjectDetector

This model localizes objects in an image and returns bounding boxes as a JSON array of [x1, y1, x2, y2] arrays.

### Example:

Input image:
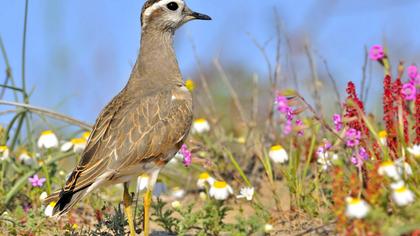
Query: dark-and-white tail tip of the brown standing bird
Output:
[[44, 189, 87, 217]]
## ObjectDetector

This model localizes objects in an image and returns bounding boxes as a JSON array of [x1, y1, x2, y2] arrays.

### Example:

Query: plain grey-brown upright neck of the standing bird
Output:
[[131, 28, 182, 87]]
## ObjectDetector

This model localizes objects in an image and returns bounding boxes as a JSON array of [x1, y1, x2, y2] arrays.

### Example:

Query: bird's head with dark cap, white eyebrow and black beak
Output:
[[141, 0, 211, 31]]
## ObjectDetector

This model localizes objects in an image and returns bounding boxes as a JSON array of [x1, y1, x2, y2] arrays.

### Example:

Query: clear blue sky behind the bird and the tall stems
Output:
[[0, 0, 420, 123]]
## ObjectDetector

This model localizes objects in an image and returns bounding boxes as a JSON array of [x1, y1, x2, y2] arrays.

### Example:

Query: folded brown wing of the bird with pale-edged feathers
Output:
[[64, 86, 192, 192]]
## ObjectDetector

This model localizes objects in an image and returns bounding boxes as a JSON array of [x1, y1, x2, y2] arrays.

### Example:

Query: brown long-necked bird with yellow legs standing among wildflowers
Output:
[[44, 0, 211, 236]]
